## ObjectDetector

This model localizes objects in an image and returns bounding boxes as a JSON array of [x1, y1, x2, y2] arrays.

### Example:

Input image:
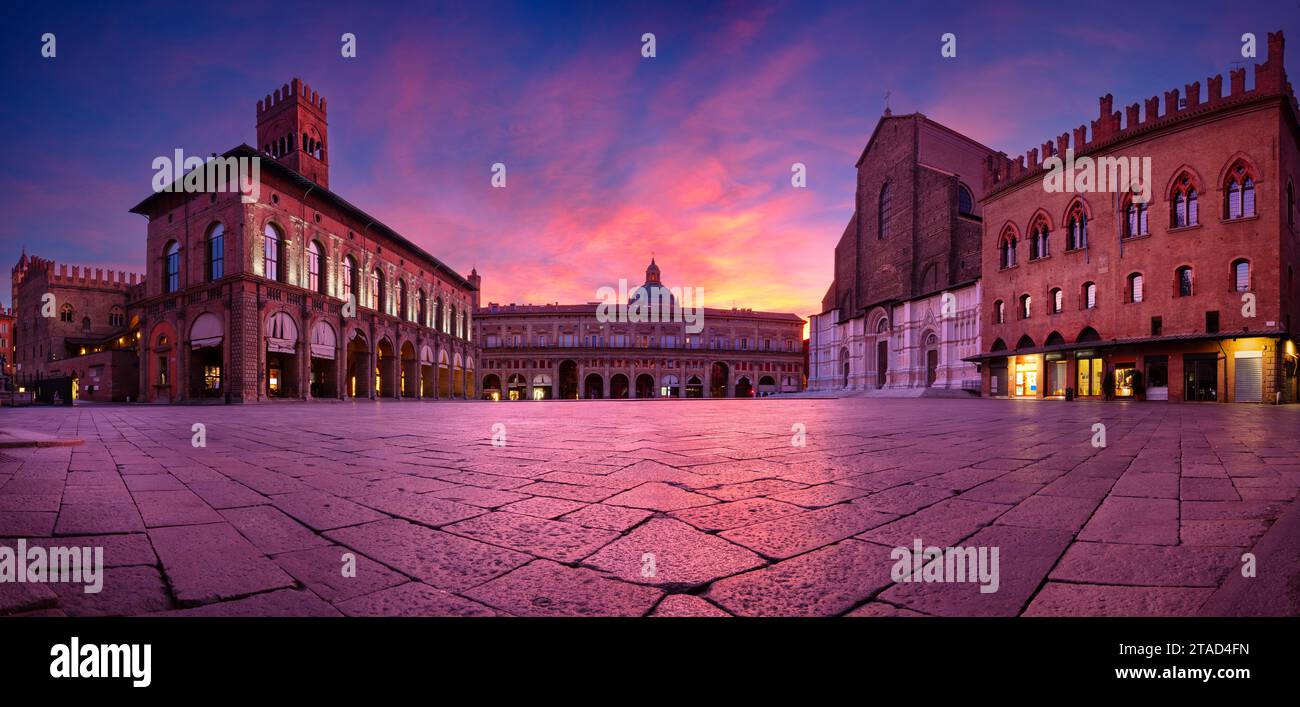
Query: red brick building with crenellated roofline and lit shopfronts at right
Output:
[[972, 32, 1300, 402]]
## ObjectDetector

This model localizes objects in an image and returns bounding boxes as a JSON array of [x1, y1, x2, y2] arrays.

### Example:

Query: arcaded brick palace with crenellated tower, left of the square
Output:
[[131, 79, 478, 403]]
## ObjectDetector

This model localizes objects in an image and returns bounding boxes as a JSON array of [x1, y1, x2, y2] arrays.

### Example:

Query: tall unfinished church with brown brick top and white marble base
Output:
[[809, 110, 993, 395]]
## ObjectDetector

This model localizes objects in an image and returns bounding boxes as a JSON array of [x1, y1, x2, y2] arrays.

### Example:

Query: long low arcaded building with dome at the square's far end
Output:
[[475, 260, 805, 400]]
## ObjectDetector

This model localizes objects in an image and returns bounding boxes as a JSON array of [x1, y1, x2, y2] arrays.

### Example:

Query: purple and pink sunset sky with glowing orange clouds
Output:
[[0, 1, 1300, 316]]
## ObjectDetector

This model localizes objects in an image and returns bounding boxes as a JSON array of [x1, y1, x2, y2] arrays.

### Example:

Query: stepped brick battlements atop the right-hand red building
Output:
[[984, 30, 1300, 194]]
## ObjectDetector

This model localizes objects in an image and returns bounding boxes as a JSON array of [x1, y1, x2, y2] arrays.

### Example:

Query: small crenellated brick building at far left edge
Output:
[[9, 252, 144, 402]]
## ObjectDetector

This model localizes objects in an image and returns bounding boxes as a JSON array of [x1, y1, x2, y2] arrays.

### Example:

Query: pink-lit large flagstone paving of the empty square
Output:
[[0, 398, 1300, 616]]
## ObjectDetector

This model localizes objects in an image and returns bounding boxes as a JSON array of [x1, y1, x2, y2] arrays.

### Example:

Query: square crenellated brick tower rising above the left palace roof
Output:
[[257, 78, 329, 188]]
